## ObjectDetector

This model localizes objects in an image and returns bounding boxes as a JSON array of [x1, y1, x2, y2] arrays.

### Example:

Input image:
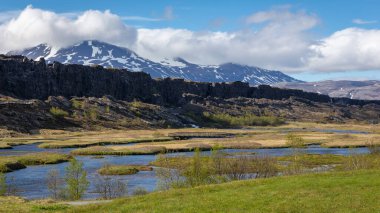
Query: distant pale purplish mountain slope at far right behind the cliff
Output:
[[275, 80, 380, 100]]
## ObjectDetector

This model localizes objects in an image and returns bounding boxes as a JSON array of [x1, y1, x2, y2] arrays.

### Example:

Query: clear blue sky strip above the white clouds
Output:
[[0, 0, 380, 35]]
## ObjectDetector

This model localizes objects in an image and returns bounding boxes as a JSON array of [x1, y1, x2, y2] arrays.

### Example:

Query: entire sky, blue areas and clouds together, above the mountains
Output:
[[0, 0, 380, 81]]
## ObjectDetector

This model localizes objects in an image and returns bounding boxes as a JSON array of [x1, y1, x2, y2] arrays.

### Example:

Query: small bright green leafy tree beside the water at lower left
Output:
[[65, 158, 89, 200]]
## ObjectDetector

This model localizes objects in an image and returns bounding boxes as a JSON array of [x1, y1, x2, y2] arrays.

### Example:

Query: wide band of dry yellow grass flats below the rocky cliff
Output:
[[0, 122, 380, 149]]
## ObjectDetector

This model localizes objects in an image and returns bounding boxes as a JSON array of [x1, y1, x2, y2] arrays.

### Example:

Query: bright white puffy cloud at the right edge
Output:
[[306, 28, 380, 71]]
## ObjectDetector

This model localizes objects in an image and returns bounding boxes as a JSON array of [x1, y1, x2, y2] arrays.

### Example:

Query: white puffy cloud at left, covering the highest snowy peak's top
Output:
[[0, 6, 137, 52]]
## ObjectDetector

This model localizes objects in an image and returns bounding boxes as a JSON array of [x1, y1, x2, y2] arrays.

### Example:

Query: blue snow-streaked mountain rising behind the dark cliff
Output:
[[8, 40, 300, 85]]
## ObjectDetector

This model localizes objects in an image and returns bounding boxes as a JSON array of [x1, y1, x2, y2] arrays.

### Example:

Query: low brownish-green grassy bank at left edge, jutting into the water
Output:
[[0, 152, 71, 173]]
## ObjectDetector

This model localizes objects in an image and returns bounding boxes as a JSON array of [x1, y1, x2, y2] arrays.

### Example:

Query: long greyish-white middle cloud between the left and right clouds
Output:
[[136, 7, 319, 70]]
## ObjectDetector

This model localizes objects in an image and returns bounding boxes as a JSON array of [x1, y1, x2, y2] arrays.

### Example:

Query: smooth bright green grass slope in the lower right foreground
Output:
[[73, 170, 380, 212]]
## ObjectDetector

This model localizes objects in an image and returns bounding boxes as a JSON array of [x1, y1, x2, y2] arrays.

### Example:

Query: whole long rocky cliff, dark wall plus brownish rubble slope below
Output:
[[0, 55, 380, 132]]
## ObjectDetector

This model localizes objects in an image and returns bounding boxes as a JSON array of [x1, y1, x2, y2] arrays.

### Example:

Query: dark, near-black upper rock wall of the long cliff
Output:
[[0, 55, 380, 106]]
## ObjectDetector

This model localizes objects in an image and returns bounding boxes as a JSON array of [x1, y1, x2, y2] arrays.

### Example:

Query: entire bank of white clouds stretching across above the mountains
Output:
[[0, 6, 380, 72]]
